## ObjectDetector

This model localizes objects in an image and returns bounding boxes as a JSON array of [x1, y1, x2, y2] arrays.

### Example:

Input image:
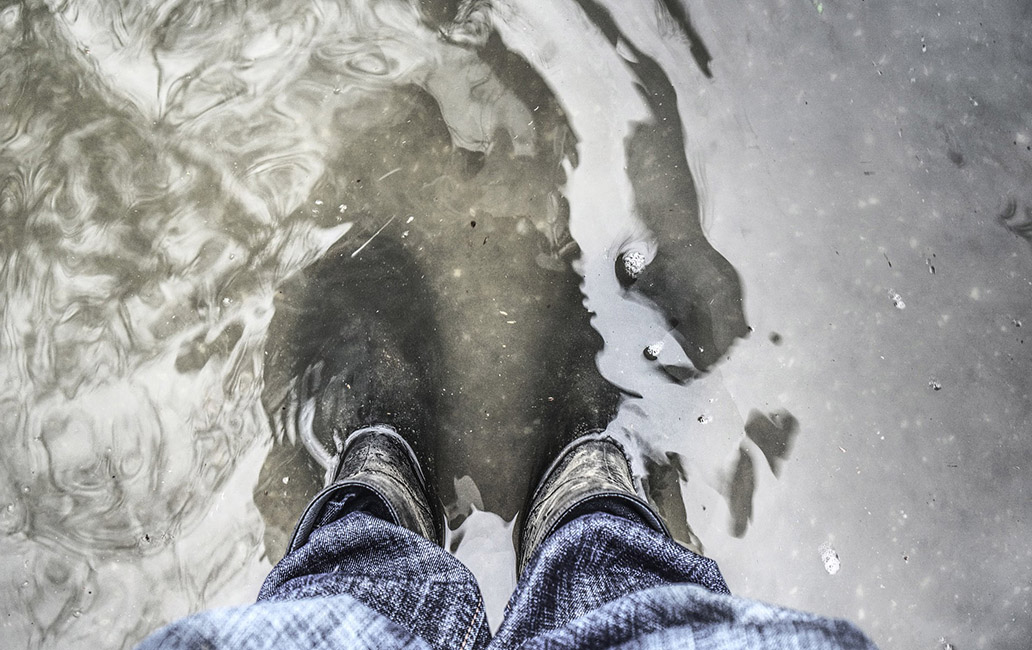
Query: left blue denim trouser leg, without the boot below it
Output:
[[140, 512, 488, 650]]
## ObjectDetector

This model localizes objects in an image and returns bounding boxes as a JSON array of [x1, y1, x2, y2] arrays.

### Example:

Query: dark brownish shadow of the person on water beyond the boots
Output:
[[255, 0, 747, 552]]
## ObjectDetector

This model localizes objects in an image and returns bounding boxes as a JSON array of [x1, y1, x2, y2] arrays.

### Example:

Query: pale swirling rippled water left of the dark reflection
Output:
[[0, 2, 553, 645]]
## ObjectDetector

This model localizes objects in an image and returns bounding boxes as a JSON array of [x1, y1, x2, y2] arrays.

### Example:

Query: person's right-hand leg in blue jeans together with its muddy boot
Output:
[[492, 441, 873, 650]]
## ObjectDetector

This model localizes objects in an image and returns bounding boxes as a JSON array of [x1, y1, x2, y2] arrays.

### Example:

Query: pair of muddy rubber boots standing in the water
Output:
[[287, 426, 670, 574]]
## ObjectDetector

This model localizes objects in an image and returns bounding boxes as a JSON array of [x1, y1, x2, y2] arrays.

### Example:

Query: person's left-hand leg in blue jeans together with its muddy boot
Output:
[[143, 427, 489, 650]]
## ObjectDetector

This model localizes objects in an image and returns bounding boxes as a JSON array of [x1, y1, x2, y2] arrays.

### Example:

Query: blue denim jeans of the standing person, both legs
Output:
[[140, 512, 874, 650]]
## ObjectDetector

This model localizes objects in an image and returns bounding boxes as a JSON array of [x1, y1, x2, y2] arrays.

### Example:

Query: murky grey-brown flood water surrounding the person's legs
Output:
[[0, 0, 1032, 650]]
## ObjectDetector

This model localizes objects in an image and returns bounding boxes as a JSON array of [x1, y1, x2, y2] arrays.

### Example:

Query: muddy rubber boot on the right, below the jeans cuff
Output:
[[516, 433, 670, 574]]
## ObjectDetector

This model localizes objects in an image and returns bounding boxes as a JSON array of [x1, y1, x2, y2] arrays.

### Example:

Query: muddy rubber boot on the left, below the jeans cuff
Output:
[[287, 425, 444, 553]]
